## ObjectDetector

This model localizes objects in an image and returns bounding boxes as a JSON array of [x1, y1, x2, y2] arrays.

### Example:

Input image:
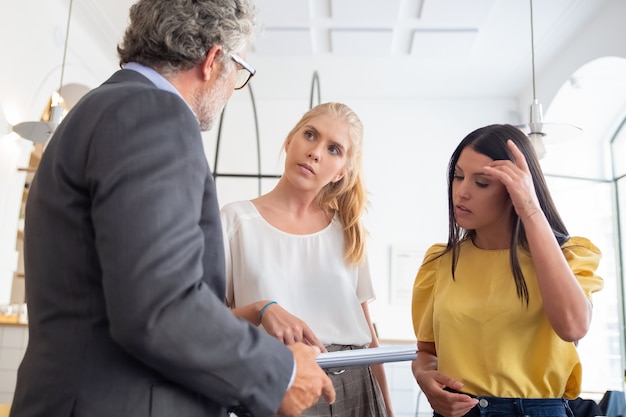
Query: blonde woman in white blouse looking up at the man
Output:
[[222, 103, 392, 417]]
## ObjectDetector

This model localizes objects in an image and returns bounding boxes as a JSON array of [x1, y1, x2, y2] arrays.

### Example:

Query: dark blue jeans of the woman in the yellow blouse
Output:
[[434, 397, 574, 417]]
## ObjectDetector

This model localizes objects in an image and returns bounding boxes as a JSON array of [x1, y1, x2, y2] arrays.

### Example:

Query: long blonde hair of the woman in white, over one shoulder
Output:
[[283, 102, 367, 264]]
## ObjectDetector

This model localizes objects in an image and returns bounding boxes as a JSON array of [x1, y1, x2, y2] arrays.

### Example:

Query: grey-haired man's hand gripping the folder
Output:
[[278, 342, 335, 417]]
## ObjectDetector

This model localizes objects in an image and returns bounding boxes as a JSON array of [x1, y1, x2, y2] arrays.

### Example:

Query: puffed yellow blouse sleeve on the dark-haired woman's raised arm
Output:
[[561, 236, 604, 300]]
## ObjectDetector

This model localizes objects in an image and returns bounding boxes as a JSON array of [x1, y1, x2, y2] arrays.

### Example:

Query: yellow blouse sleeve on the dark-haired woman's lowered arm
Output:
[[411, 244, 446, 342]]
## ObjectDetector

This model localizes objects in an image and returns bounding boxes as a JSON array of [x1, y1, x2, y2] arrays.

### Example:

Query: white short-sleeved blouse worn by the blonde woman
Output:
[[221, 201, 374, 345]]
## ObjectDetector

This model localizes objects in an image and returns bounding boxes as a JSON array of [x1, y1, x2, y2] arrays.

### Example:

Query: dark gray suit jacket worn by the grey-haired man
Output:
[[11, 70, 293, 417]]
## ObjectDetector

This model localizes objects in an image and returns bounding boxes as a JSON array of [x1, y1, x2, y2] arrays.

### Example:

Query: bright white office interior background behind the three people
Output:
[[0, 0, 626, 416]]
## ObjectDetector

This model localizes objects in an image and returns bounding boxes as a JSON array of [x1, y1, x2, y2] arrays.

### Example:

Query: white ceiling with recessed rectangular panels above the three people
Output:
[[44, 0, 622, 101]]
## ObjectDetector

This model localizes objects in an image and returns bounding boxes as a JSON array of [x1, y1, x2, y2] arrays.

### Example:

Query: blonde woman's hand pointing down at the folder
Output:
[[261, 304, 326, 352]]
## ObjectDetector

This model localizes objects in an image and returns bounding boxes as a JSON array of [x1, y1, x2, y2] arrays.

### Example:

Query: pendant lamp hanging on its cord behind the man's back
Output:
[[13, 0, 74, 144]]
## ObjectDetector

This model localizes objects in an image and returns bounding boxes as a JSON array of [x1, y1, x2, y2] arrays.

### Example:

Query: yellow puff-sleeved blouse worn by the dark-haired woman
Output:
[[412, 237, 603, 399]]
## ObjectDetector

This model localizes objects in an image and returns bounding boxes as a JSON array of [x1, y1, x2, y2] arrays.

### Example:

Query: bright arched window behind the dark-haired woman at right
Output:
[[541, 57, 626, 396]]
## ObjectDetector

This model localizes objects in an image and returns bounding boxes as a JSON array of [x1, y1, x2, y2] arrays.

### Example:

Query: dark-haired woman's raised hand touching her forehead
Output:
[[484, 140, 541, 221]]
